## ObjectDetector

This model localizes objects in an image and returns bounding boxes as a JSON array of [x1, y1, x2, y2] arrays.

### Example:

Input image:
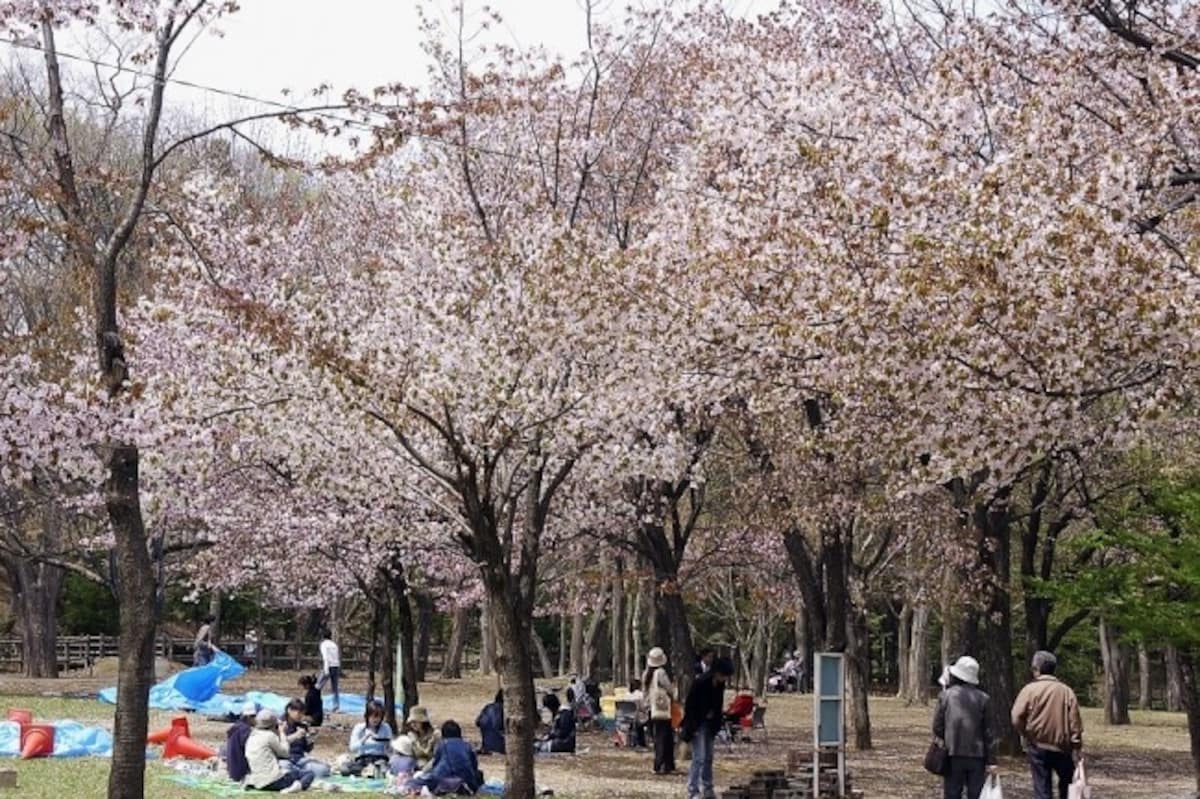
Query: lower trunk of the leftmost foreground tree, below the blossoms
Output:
[[106, 444, 157, 799]]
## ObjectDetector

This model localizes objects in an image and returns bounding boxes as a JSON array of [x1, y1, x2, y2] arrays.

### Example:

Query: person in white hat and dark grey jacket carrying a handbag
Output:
[[934, 656, 996, 799]]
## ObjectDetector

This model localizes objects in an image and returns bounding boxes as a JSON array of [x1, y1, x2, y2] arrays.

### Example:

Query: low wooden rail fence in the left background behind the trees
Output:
[[0, 636, 479, 674]]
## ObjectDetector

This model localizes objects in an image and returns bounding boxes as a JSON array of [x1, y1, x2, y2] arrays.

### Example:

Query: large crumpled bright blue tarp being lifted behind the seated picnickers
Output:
[[100, 651, 366, 716]]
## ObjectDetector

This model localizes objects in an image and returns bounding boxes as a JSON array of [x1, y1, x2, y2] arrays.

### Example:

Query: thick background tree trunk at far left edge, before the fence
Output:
[[5, 558, 66, 678]]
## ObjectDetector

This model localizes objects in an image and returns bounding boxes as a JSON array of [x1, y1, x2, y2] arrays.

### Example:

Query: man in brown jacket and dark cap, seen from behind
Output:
[[1013, 651, 1084, 799]]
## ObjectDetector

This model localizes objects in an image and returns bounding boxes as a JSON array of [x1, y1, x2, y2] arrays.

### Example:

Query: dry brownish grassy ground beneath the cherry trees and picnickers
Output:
[[0, 673, 1195, 799]]
